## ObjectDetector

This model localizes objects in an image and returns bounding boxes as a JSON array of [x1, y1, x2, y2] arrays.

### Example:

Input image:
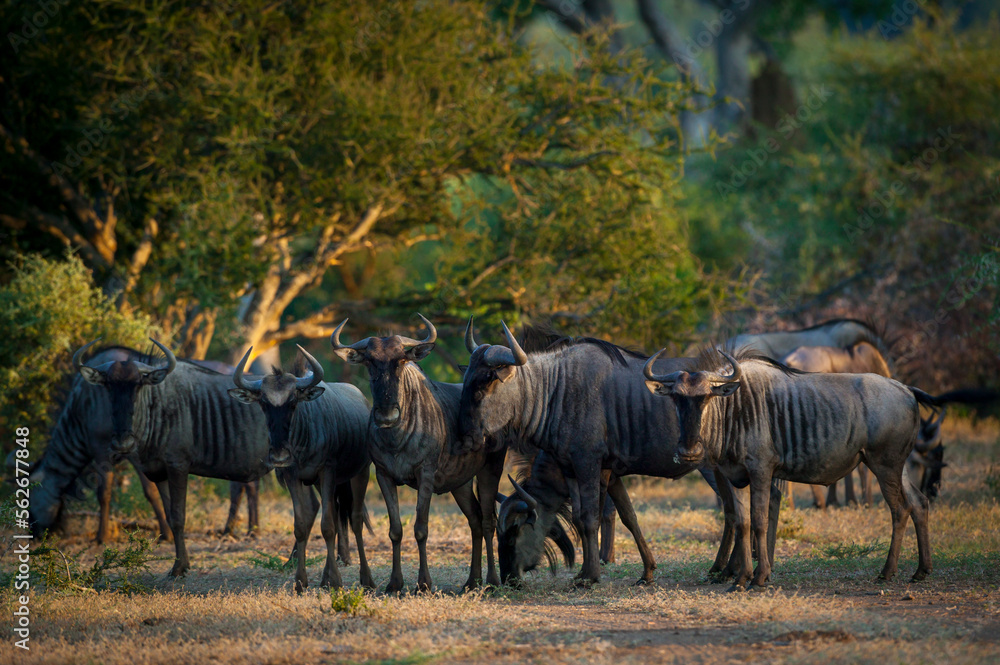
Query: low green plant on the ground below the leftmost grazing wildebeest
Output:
[[31, 530, 156, 594]]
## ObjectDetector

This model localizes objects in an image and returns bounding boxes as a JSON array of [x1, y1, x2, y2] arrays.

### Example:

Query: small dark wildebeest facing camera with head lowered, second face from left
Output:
[[229, 346, 375, 593]]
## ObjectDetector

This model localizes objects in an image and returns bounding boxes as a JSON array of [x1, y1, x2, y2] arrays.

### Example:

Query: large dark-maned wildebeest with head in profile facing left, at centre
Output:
[[459, 320, 780, 582]]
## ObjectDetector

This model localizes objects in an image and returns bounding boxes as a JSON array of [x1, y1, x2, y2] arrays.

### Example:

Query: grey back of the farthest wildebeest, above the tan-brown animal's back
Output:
[[723, 319, 889, 361]]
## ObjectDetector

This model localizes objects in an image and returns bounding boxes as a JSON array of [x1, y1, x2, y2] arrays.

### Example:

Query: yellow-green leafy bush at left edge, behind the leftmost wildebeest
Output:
[[0, 254, 155, 446]]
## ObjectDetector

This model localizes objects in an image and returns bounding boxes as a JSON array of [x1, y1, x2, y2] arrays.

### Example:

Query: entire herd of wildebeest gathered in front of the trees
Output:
[[25, 316, 982, 592]]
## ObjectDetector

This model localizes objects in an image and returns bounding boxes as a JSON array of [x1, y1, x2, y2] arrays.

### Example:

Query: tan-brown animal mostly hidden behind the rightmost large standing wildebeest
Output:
[[775, 342, 892, 509]]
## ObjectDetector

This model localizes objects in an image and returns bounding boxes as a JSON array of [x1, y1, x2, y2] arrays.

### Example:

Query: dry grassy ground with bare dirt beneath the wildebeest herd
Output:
[[0, 421, 1000, 665]]
